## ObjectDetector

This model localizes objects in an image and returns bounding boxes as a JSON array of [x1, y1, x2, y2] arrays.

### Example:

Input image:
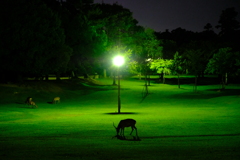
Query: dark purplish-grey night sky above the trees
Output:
[[94, 0, 240, 32]]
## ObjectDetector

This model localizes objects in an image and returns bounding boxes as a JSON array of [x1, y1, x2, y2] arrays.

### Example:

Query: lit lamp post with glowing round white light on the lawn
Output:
[[113, 56, 124, 113]]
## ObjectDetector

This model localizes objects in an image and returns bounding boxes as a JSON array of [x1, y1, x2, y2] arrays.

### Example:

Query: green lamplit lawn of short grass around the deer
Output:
[[0, 79, 240, 160]]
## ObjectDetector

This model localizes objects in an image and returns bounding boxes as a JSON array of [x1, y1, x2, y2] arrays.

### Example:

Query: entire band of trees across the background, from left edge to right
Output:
[[0, 0, 240, 82]]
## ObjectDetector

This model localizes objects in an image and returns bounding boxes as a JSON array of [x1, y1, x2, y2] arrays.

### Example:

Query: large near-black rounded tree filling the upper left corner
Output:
[[0, 0, 71, 80]]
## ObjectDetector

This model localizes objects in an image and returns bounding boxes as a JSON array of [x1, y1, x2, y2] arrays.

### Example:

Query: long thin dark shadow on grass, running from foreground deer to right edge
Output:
[[142, 133, 240, 139]]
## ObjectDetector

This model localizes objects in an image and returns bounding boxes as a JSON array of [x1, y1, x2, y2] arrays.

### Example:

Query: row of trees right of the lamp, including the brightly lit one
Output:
[[152, 8, 240, 88]]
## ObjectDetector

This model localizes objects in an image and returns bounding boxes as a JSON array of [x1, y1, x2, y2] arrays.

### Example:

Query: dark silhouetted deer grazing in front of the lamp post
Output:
[[113, 119, 137, 137]]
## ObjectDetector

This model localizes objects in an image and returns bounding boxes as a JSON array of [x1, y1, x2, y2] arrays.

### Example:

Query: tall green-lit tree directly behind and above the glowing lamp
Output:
[[88, 3, 140, 77]]
